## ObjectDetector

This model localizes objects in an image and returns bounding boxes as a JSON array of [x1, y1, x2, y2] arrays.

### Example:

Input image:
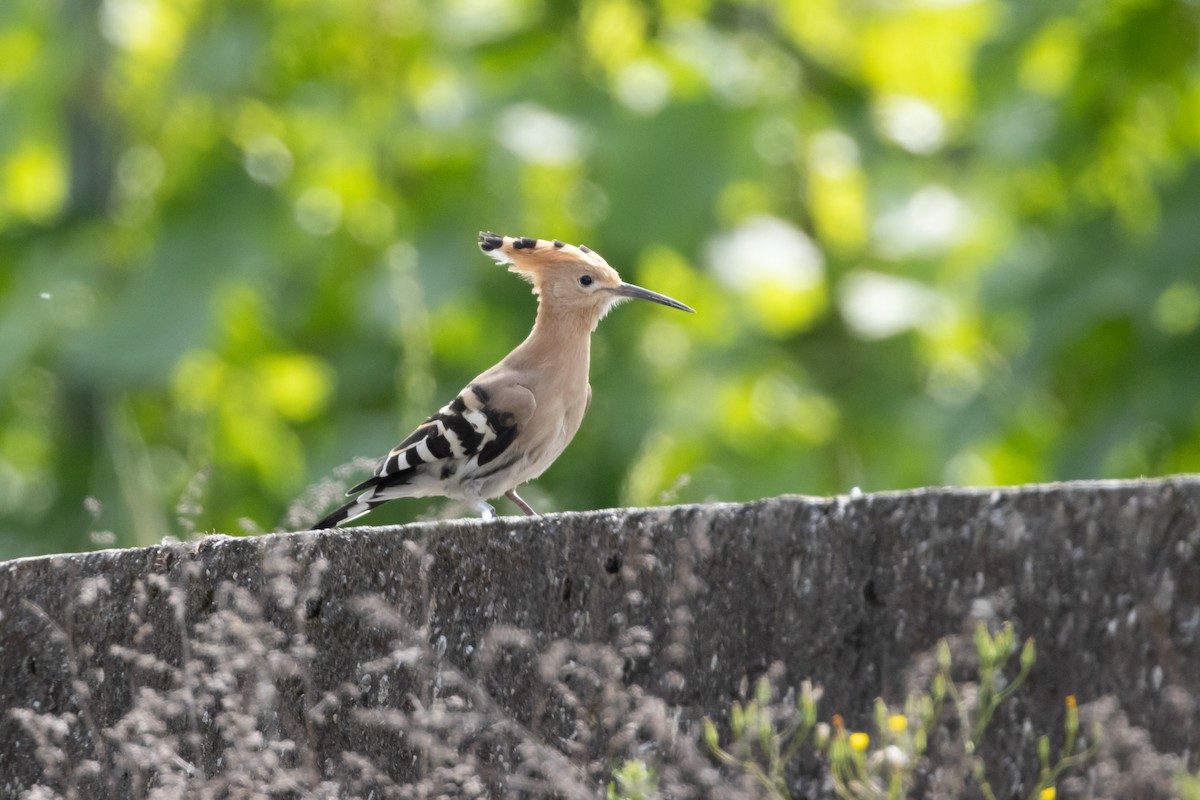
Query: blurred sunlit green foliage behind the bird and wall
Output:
[[0, 0, 1200, 558]]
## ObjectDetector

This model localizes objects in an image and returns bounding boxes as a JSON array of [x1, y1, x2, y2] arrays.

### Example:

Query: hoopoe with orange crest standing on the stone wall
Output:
[[316, 231, 692, 528]]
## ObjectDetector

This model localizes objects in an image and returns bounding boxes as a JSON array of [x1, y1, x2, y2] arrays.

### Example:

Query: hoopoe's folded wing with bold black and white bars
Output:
[[347, 381, 538, 494]]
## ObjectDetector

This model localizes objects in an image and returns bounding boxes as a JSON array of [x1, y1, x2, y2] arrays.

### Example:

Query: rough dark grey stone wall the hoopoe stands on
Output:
[[0, 476, 1200, 798]]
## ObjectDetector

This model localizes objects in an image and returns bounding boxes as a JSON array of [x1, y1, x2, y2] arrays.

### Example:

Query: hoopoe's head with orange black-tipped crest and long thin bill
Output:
[[479, 231, 694, 326]]
